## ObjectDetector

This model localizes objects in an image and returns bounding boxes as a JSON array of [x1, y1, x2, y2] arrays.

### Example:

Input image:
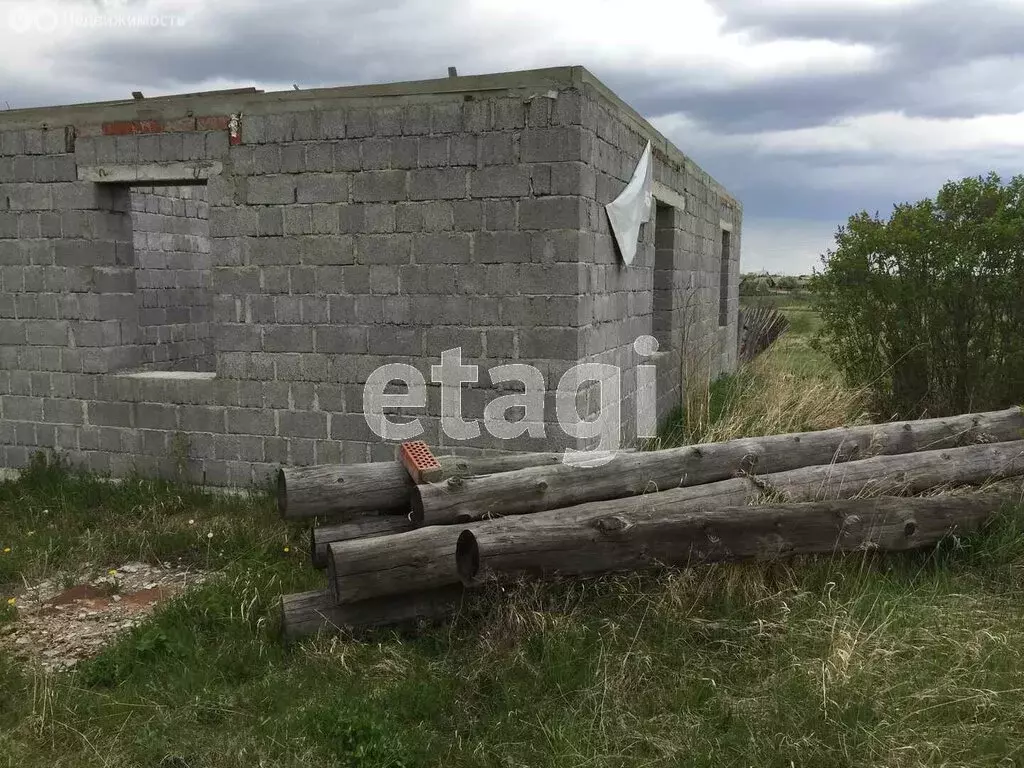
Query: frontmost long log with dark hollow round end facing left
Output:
[[456, 493, 1020, 586]]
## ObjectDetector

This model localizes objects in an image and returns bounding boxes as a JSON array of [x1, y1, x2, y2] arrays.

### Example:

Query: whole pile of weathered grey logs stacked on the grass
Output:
[[278, 408, 1024, 639]]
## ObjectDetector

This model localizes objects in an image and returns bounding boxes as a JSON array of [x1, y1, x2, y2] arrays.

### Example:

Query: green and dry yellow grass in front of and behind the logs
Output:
[[0, 311, 1024, 768]]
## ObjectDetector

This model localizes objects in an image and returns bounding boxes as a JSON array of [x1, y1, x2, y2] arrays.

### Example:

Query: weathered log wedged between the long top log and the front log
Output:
[[328, 440, 1024, 602]]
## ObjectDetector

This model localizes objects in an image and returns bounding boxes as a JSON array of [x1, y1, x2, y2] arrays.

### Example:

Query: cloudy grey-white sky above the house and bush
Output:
[[0, 0, 1024, 273]]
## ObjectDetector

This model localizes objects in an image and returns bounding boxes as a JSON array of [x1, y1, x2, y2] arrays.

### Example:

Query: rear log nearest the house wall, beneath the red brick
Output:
[[278, 453, 585, 520]]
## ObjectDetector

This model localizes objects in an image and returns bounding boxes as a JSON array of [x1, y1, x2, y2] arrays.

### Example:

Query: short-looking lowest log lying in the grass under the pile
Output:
[[281, 587, 464, 641]]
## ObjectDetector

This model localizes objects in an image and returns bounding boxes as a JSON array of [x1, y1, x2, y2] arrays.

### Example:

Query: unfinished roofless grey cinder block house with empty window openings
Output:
[[0, 68, 741, 484]]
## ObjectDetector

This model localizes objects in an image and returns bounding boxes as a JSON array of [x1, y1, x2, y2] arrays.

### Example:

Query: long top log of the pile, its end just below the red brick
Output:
[[412, 408, 1024, 525]]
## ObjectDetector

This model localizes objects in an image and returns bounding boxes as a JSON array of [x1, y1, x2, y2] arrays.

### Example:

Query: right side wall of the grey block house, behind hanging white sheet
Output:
[[578, 82, 742, 443]]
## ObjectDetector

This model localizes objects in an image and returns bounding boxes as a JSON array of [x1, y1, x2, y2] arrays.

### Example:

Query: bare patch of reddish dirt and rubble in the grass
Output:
[[0, 562, 210, 670]]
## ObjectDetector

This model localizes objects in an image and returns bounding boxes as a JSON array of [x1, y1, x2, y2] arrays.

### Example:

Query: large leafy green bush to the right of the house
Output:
[[812, 174, 1024, 418]]
